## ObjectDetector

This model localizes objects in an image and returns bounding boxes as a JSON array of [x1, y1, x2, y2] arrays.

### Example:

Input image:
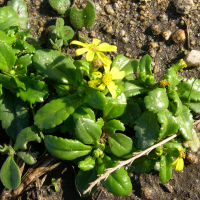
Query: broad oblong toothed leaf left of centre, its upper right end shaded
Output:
[[34, 93, 82, 129]]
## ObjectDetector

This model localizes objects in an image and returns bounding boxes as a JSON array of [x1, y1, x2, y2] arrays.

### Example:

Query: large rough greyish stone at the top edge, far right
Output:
[[174, 0, 195, 14]]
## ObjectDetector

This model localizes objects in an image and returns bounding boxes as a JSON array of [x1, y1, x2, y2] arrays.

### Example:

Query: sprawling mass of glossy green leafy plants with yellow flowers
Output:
[[0, 0, 200, 196]]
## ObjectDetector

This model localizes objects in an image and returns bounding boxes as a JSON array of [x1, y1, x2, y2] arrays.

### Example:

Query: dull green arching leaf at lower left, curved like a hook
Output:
[[14, 126, 42, 150]]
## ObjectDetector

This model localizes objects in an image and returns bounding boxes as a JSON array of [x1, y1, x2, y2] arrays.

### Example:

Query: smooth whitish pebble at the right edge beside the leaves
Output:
[[184, 50, 200, 67]]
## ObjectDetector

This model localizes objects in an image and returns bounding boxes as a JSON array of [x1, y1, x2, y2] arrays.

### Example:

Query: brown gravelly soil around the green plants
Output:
[[0, 0, 200, 200]]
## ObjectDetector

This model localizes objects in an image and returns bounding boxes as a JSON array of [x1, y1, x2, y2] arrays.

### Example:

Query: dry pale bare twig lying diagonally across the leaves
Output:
[[83, 134, 177, 194]]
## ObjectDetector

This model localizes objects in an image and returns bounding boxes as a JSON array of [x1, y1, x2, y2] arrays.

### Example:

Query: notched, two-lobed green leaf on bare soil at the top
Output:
[[70, 1, 95, 29]]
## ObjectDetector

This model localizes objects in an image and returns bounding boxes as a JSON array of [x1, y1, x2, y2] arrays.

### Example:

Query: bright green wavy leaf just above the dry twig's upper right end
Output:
[[158, 110, 179, 140]]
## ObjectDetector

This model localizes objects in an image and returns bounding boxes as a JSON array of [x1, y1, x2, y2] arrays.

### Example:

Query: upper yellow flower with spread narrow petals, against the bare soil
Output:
[[70, 38, 117, 65]]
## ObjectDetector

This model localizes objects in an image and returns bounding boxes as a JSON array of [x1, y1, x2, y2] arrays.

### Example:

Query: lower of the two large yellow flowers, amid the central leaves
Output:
[[88, 66, 125, 98]]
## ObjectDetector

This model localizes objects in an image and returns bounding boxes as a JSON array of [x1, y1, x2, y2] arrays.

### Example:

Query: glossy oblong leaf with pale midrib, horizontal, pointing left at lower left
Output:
[[44, 135, 92, 160]]
